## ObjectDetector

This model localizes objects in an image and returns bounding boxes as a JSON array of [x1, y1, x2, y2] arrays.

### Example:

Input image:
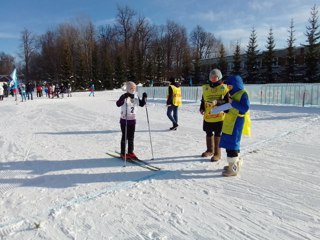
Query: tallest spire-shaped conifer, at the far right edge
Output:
[[305, 5, 320, 82]]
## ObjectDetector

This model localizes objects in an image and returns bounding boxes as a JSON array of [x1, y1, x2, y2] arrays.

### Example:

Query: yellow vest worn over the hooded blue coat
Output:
[[222, 90, 251, 136]]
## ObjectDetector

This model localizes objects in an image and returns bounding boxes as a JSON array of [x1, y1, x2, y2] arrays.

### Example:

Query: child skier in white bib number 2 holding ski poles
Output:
[[116, 81, 147, 159]]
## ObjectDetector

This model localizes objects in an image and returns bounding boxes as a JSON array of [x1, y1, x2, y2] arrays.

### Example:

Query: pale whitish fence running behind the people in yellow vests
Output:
[[138, 83, 320, 107]]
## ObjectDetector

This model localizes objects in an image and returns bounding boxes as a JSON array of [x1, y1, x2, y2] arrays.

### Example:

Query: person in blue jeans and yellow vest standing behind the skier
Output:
[[167, 77, 182, 130]]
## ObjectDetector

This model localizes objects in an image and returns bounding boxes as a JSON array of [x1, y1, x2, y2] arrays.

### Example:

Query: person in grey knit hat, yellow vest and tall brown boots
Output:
[[200, 69, 229, 162]]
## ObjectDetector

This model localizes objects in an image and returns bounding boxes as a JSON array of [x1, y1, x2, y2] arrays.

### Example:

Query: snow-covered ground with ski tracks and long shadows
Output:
[[0, 91, 320, 240]]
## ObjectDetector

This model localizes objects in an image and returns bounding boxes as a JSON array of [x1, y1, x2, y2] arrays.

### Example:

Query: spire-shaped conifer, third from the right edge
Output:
[[263, 28, 276, 83]]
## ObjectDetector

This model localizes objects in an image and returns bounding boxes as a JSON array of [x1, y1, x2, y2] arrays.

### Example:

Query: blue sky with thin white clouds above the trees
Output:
[[0, 0, 320, 56]]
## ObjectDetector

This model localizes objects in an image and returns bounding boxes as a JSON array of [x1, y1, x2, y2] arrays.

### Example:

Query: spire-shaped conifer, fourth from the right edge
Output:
[[246, 28, 259, 83]]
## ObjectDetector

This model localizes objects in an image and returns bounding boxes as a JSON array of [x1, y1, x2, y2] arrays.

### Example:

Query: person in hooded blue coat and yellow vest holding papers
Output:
[[220, 75, 250, 177]]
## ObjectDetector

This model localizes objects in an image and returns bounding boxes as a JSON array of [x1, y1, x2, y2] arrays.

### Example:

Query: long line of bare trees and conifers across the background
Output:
[[0, 5, 320, 89]]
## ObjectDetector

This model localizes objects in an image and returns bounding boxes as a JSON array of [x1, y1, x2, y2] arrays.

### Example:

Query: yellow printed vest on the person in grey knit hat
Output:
[[202, 84, 229, 122]]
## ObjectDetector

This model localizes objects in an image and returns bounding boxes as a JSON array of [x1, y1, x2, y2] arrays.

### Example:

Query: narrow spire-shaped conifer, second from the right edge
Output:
[[286, 19, 296, 82]]
